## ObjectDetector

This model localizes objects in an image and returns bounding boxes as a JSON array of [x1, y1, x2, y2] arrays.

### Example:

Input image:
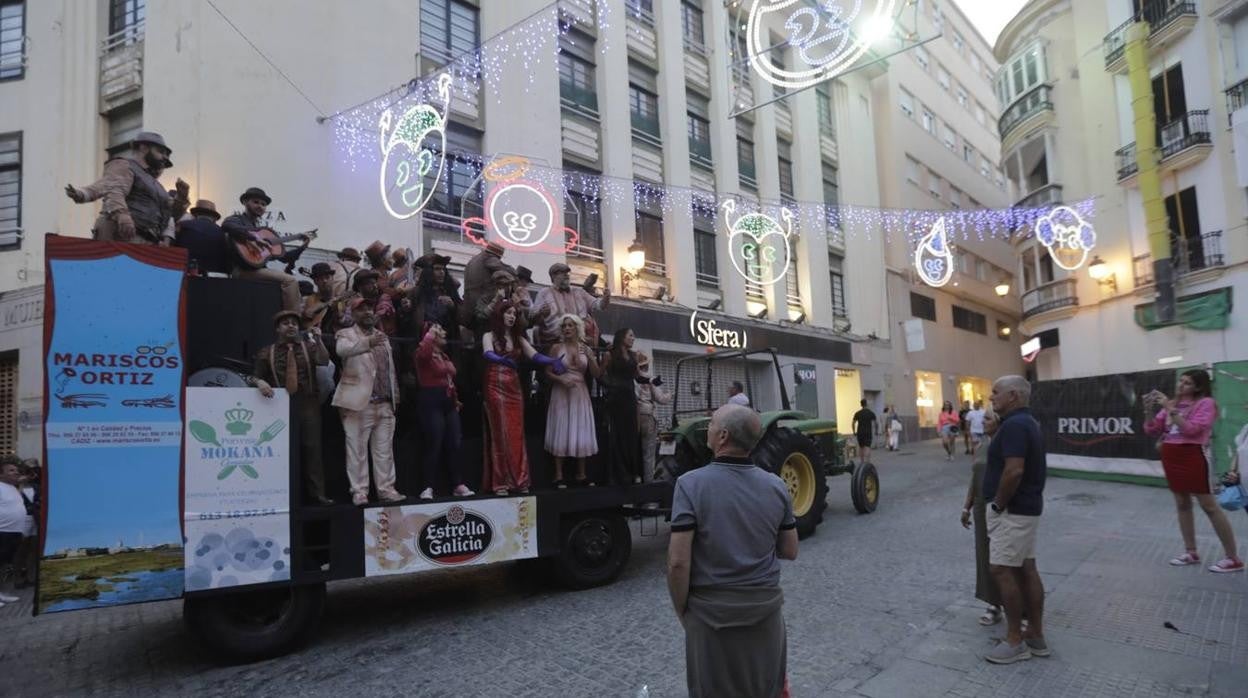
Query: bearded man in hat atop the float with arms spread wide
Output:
[[65, 131, 190, 245]]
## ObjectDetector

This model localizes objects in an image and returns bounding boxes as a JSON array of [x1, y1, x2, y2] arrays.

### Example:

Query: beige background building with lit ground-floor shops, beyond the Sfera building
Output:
[[872, 0, 1023, 436]]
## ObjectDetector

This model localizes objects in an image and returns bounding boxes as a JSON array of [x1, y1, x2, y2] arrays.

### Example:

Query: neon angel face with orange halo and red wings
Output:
[[461, 156, 580, 252]]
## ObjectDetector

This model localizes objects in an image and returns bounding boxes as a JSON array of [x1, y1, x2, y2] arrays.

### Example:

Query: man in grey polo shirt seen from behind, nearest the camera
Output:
[[668, 405, 797, 698]]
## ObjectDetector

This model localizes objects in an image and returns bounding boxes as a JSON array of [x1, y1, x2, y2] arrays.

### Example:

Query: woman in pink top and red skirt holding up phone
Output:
[[1144, 370, 1244, 572]]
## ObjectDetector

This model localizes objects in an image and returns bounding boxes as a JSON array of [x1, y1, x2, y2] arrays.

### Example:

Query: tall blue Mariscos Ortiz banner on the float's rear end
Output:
[[36, 235, 186, 612]]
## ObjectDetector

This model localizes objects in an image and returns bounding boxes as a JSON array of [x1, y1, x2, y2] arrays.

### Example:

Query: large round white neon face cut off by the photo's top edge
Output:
[[745, 0, 899, 90]]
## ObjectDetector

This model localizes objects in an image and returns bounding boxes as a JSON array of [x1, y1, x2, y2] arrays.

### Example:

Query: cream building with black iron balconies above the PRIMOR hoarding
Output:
[[995, 0, 1248, 381]]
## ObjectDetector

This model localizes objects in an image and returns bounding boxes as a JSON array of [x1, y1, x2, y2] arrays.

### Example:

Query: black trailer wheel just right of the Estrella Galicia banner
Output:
[[554, 512, 633, 589]]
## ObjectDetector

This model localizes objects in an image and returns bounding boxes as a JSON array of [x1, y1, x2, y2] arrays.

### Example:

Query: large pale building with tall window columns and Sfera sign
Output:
[[0, 0, 928, 456]]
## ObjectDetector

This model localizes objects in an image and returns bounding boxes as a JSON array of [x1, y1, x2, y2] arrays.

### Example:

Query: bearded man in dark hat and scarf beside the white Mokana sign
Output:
[[252, 310, 333, 504]]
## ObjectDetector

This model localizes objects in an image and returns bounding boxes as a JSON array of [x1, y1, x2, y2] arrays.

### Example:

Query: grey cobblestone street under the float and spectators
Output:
[[0, 442, 1248, 698]]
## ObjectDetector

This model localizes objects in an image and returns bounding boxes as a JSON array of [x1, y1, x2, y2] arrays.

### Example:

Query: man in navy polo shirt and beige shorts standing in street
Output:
[[983, 376, 1050, 664]]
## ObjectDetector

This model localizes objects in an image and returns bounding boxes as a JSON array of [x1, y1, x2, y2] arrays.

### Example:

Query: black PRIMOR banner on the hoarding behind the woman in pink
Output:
[[1031, 371, 1174, 477]]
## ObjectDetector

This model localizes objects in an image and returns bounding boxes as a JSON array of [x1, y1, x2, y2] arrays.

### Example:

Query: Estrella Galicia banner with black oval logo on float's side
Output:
[[364, 497, 538, 577]]
